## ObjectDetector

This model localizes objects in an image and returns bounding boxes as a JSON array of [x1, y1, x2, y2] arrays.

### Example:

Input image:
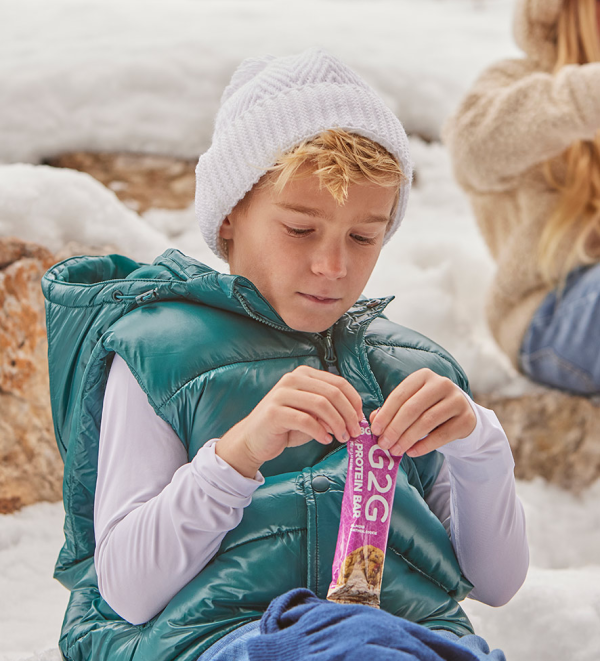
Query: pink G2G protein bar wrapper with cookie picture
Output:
[[327, 418, 402, 608]]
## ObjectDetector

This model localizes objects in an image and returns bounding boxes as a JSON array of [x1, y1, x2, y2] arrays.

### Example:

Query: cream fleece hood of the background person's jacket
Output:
[[513, 0, 563, 71]]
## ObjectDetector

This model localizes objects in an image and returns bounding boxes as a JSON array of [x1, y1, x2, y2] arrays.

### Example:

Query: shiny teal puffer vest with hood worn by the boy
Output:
[[42, 250, 472, 661]]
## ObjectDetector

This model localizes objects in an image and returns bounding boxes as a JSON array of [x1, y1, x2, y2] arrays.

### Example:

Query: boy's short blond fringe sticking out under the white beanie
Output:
[[221, 128, 407, 255]]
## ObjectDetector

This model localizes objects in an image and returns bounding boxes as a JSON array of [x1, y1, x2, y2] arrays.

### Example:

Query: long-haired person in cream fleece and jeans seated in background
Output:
[[443, 0, 600, 395]]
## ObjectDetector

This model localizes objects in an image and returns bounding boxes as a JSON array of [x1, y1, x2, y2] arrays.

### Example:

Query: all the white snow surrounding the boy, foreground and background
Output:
[[0, 0, 600, 661]]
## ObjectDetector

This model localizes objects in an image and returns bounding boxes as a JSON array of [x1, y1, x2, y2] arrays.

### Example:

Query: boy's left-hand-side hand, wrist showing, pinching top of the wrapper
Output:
[[215, 365, 363, 477]]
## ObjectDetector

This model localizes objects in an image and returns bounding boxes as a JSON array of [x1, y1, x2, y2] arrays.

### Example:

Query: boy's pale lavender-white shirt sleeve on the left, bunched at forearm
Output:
[[94, 355, 264, 624]]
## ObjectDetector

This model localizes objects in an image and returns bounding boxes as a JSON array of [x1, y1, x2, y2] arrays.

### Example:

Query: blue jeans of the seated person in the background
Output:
[[519, 264, 600, 395]]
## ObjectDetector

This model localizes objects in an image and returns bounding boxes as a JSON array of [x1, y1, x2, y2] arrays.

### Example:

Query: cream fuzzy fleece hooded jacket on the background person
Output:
[[442, 0, 600, 368]]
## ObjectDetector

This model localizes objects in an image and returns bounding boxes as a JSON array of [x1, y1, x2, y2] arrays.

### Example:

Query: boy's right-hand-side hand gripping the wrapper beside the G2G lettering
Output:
[[370, 368, 477, 457]]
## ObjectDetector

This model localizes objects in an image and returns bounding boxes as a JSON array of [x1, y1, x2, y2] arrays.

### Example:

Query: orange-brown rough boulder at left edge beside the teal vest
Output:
[[0, 238, 63, 513]]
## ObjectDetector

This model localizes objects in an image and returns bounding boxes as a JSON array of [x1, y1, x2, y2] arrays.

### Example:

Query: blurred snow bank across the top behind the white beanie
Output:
[[0, 0, 518, 163]]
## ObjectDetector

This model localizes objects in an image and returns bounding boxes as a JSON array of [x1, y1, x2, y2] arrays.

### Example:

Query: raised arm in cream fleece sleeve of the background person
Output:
[[442, 60, 600, 192]]
